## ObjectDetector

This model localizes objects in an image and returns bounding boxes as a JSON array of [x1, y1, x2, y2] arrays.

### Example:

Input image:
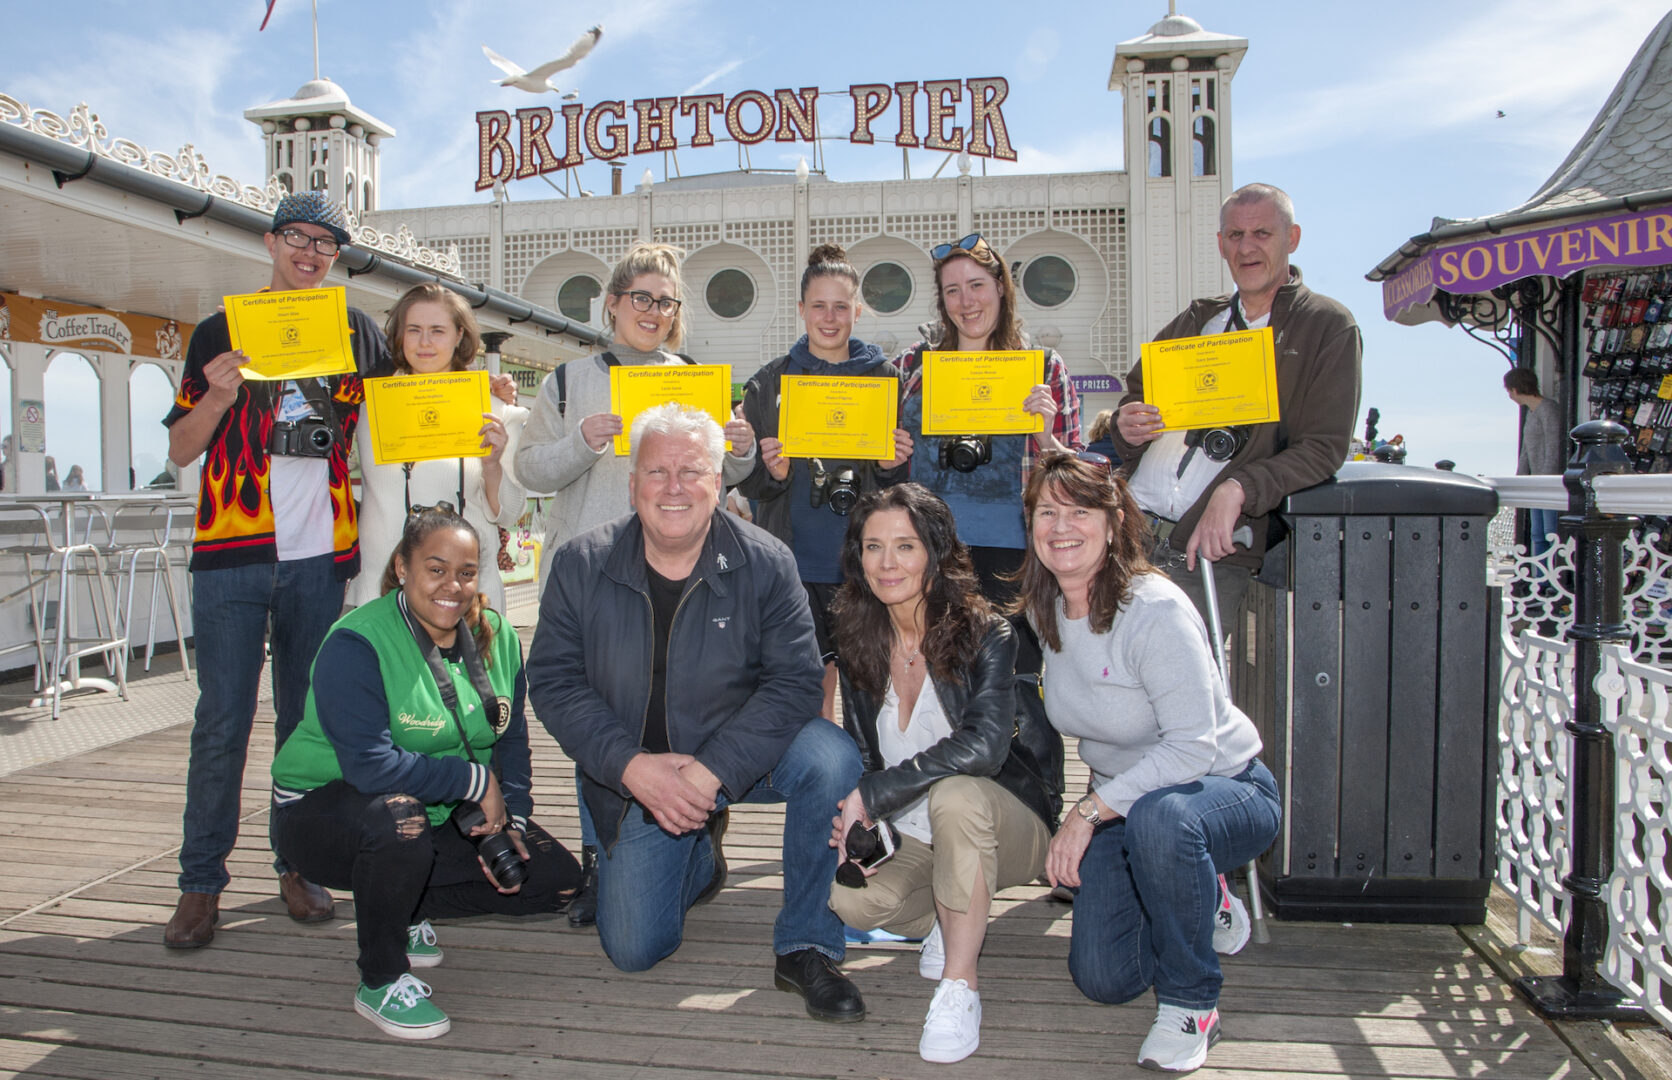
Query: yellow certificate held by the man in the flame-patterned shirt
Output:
[[226, 288, 354, 380]]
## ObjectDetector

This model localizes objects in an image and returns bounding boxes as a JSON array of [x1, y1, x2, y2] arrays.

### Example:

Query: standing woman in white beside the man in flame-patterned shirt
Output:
[[348, 283, 528, 614]]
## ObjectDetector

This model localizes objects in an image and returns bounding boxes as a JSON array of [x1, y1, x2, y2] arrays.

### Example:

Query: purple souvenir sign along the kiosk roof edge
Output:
[[1381, 207, 1672, 319]]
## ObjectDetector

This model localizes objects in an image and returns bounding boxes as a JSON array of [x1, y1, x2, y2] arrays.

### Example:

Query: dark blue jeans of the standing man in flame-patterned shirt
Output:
[[181, 555, 343, 893]]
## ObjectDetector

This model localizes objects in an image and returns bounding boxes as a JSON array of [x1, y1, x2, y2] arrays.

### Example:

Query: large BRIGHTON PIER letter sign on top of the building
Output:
[[477, 77, 1017, 191]]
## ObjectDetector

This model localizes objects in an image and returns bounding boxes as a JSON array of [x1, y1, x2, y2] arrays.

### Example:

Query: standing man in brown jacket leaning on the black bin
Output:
[[1114, 184, 1364, 619]]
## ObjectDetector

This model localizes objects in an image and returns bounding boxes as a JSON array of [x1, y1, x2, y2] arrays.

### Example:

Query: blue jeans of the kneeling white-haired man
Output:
[[599, 719, 863, 971]]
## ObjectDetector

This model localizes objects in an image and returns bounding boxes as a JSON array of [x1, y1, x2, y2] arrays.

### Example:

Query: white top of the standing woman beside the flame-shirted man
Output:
[[348, 398, 528, 615]]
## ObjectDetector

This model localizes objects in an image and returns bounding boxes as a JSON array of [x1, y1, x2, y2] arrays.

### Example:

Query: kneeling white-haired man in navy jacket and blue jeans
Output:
[[527, 405, 864, 1023]]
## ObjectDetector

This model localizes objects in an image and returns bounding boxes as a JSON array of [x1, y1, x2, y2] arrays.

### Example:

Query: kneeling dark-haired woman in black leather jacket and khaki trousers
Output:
[[831, 483, 1062, 1062]]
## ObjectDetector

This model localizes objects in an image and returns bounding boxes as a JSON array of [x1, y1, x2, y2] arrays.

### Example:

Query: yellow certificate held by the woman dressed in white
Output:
[[366, 371, 492, 465]]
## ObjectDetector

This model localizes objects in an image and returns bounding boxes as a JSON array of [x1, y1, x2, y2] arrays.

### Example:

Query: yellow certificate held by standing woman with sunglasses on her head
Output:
[[922, 349, 1045, 434]]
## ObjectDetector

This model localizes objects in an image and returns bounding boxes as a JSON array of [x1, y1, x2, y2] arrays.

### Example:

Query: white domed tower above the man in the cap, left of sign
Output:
[[244, 79, 395, 222]]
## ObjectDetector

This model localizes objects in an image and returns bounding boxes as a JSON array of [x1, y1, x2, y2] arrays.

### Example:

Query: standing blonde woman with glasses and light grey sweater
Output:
[[513, 244, 756, 926]]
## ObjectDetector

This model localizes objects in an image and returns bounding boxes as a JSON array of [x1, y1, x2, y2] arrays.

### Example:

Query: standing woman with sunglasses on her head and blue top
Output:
[[900, 234, 1083, 674]]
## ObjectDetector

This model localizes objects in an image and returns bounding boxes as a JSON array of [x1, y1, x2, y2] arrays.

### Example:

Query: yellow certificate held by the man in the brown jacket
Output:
[[1144, 326, 1277, 431]]
